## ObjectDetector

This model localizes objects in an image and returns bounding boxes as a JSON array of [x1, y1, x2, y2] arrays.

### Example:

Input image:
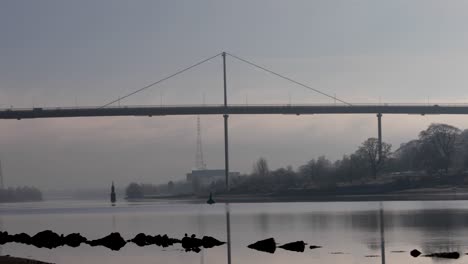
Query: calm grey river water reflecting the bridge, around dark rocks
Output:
[[0, 201, 468, 264]]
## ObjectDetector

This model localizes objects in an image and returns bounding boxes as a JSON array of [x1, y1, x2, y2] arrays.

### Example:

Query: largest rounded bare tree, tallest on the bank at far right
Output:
[[419, 124, 461, 172]]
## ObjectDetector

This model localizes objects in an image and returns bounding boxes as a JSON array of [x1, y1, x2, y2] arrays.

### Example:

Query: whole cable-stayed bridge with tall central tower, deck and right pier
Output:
[[0, 52, 468, 190]]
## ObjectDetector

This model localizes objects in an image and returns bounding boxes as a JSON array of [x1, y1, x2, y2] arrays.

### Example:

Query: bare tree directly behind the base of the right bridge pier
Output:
[[356, 138, 392, 178]]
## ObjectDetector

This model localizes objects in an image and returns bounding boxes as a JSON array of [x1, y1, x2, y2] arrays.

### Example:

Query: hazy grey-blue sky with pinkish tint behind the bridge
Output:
[[0, 0, 468, 190]]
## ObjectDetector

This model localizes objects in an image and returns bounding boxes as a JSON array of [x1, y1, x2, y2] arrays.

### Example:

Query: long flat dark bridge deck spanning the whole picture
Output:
[[0, 104, 468, 120]]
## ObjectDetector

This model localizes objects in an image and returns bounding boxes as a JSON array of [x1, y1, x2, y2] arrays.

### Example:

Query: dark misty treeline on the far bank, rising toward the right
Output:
[[127, 124, 468, 197]]
